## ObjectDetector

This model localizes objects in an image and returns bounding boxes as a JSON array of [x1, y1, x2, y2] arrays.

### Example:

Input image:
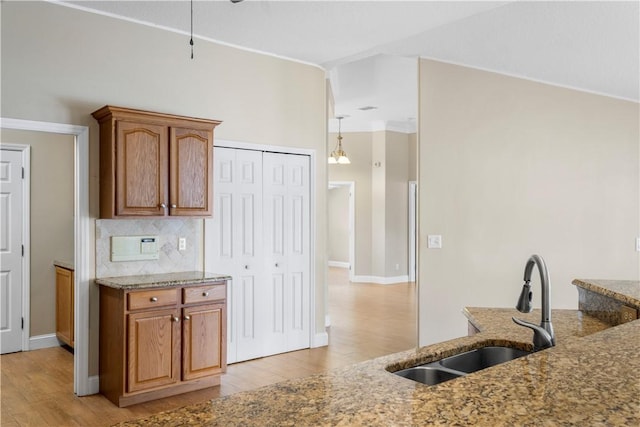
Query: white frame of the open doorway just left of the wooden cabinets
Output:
[[0, 117, 91, 396]]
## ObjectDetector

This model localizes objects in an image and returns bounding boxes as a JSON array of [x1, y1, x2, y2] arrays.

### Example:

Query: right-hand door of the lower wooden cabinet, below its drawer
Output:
[[182, 304, 226, 380]]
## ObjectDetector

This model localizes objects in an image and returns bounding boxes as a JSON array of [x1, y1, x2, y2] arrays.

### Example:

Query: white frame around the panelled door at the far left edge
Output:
[[0, 143, 31, 351]]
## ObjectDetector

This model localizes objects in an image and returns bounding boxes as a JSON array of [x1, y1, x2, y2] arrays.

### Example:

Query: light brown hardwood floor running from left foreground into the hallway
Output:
[[0, 268, 417, 427]]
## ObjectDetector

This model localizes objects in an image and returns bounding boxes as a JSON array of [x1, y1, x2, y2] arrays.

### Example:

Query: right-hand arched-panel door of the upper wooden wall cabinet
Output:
[[169, 128, 213, 216]]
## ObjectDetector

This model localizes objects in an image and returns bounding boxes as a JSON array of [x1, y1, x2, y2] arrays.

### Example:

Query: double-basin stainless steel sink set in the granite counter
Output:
[[394, 346, 531, 385]]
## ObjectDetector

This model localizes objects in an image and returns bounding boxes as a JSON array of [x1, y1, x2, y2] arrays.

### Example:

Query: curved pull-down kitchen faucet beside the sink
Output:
[[512, 255, 556, 351]]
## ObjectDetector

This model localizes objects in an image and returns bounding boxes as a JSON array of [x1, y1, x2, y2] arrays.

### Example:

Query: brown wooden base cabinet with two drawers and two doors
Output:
[[100, 282, 227, 407]]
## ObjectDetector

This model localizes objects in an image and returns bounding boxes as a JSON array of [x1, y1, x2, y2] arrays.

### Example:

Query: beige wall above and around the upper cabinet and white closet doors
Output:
[[1, 2, 327, 374]]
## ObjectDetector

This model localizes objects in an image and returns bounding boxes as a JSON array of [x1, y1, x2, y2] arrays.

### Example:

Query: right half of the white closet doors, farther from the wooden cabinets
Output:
[[263, 153, 310, 354]]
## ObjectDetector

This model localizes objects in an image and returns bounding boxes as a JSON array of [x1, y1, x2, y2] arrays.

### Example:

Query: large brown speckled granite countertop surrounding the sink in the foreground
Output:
[[116, 281, 640, 426]]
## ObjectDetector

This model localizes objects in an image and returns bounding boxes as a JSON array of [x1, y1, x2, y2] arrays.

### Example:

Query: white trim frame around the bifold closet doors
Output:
[[211, 138, 329, 348]]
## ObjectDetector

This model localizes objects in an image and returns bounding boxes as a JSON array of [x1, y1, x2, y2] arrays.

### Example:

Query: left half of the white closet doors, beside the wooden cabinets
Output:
[[205, 147, 266, 363]]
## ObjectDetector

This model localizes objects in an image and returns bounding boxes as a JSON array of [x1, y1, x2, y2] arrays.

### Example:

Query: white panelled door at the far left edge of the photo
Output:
[[0, 149, 25, 354]]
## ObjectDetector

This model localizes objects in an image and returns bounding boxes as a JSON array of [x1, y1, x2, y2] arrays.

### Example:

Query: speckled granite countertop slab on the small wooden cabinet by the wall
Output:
[[96, 271, 231, 290]]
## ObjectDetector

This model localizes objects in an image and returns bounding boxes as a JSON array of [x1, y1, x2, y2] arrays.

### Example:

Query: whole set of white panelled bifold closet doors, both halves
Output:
[[205, 147, 311, 363]]
